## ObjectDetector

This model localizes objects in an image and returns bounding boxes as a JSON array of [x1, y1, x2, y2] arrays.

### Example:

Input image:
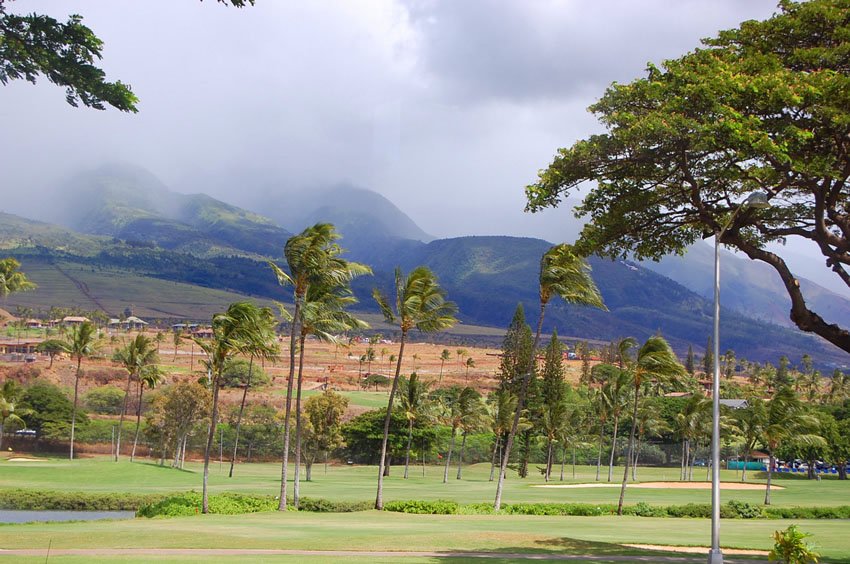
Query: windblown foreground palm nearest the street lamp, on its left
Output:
[[617, 337, 684, 515]]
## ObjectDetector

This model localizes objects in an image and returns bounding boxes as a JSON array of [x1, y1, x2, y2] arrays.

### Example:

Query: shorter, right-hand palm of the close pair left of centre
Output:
[[292, 283, 366, 509]]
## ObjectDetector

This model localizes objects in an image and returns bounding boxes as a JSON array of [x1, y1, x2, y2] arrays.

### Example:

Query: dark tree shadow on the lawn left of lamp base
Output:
[[424, 537, 767, 564]]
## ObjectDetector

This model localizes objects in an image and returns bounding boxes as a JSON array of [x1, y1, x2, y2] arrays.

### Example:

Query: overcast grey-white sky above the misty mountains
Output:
[[0, 0, 776, 240]]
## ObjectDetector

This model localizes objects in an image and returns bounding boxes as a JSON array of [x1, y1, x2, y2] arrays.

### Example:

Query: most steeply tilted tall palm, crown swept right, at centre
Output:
[[493, 243, 606, 511]]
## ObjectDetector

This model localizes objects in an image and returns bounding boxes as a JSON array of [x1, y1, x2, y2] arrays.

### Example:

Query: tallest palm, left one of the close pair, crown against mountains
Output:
[[269, 223, 372, 511]]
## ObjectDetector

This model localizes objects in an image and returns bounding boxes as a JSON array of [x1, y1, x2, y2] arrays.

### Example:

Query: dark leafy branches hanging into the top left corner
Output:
[[0, 0, 254, 112]]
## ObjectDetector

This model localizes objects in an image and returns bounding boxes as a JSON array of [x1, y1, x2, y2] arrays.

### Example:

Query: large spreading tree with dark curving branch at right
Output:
[[526, 0, 850, 352]]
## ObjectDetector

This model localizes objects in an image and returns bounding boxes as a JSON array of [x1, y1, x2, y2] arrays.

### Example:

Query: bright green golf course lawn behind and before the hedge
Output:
[[0, 458, 850, 562]]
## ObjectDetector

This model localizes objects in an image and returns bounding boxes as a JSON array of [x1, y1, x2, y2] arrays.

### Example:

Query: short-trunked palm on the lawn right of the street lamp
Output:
[[760, 385, 826, 505]]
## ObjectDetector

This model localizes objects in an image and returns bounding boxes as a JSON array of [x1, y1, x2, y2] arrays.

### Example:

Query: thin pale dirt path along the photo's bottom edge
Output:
[[0, 548, 767, 564]]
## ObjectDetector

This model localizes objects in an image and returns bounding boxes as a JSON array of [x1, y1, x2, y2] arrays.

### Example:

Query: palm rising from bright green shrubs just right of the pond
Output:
[[195, 302, 264, 513]]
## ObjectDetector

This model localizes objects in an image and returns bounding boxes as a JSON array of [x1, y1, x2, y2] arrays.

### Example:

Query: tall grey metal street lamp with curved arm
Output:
[[708, 192, 770, 564]]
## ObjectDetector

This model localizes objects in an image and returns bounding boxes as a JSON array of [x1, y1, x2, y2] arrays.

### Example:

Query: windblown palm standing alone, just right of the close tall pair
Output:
[[372, 266, 457, 509]]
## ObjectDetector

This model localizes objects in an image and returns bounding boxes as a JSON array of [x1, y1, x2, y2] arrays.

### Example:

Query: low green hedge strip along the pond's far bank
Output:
[[0, 490, 163, 511]]
